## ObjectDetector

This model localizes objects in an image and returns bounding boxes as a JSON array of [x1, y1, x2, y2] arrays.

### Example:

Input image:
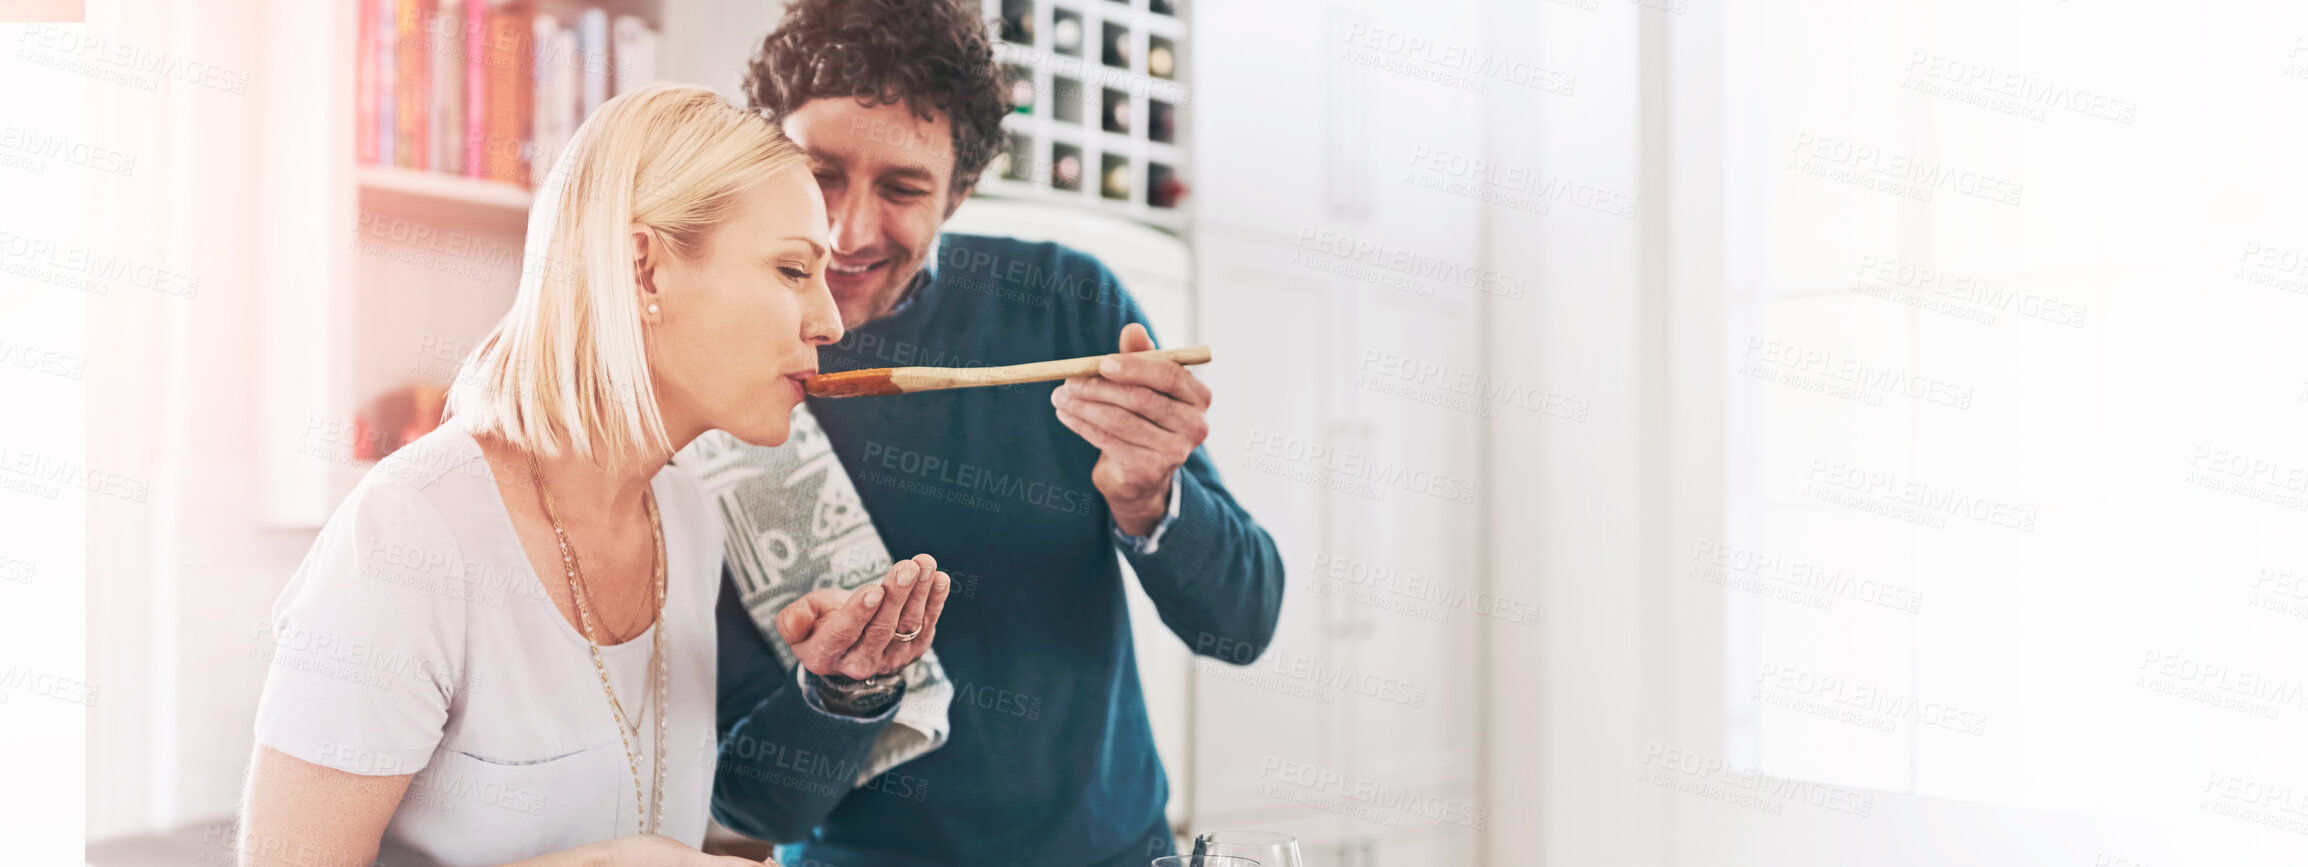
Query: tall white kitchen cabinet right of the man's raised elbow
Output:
[[1186, 0, 1486, 867]]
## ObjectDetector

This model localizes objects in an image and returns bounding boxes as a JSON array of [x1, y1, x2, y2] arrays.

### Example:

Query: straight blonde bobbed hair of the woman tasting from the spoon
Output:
[[448, 85, 805, 466]]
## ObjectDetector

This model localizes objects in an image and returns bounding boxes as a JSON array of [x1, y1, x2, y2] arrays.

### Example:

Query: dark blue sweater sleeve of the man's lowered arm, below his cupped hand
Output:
[[713, 574, 891, 844]]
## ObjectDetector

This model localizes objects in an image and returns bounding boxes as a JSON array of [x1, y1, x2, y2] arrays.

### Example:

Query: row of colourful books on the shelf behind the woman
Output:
[[353, 0, 658, 187]]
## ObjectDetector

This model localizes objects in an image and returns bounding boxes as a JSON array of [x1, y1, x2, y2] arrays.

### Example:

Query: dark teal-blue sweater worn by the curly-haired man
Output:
[[713, 235, 1283, 867]]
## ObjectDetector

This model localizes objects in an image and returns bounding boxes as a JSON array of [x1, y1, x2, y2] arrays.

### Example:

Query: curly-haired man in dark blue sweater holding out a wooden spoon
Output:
[[713, 0, 1283, 865]]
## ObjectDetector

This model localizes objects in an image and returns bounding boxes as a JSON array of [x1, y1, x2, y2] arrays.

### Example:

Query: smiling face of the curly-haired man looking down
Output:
[[782, 97, 969, 327]]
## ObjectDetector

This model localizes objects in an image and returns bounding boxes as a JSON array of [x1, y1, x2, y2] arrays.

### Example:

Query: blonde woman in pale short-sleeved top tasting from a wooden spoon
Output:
[[240, 85, 949, 867]]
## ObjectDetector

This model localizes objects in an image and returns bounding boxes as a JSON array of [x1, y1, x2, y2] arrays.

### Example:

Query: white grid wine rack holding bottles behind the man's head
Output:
[[979, 0, 1193, 233]]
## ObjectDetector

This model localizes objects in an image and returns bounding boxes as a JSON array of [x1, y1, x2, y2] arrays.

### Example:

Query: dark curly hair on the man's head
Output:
[[745, 0, 1011, 196]]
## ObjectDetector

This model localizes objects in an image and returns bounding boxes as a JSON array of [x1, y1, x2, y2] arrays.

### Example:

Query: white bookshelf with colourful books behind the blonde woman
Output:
[[258, 0, 685, 528]]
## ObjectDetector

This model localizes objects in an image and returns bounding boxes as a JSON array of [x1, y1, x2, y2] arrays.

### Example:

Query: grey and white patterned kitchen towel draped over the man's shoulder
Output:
[[674, 406, 953, 786]]
